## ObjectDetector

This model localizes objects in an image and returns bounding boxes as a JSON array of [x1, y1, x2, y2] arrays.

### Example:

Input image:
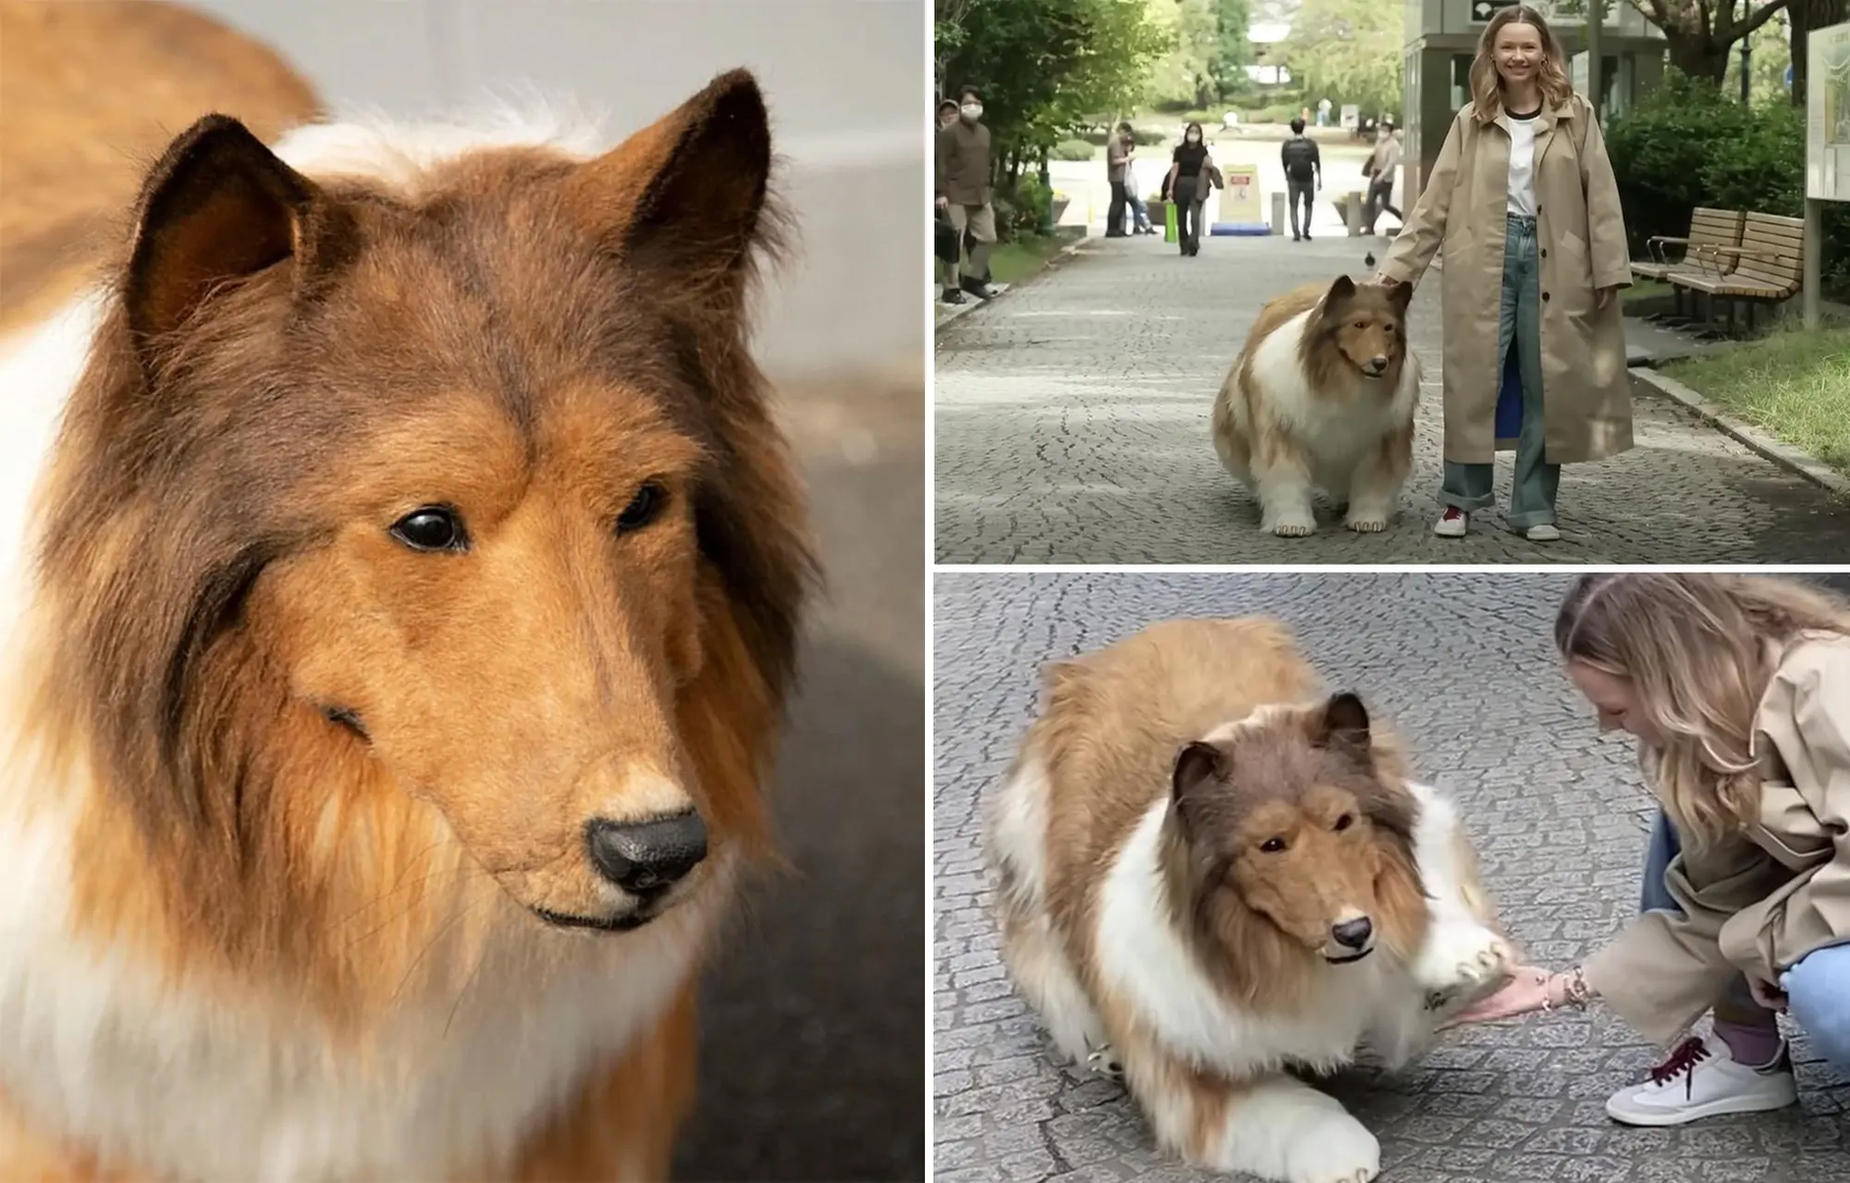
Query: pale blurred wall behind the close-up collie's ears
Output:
[[191, 0, 931, 376]]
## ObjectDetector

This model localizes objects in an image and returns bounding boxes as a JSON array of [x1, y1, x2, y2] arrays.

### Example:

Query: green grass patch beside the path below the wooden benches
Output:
[[1663, 328, 1850, 472]]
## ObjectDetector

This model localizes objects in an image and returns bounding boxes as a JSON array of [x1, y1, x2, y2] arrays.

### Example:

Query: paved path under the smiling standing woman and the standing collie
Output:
[[934, 235, 1850, 563]]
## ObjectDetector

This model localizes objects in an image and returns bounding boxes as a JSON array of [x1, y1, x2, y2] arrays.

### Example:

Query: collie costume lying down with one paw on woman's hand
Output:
[[986, 618, 1513, 1183]]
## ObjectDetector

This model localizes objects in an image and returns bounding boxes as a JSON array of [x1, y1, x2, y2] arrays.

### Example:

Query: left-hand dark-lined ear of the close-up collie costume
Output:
[[122, 115, 336, 344]]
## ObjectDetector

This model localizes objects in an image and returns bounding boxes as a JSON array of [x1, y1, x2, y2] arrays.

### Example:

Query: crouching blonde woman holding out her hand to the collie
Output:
[[1462, 574, 1850, 1126]]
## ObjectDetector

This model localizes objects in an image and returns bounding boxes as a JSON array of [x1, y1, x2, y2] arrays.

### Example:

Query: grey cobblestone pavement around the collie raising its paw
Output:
[[932, 572, 1850, 1183]]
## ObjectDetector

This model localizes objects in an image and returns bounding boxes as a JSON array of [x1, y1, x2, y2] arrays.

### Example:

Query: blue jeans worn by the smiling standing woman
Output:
[[1439, 215, 1561, 529]]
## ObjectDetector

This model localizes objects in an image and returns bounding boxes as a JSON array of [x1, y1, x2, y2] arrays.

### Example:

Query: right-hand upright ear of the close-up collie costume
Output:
[[568, 70, 771, 307]]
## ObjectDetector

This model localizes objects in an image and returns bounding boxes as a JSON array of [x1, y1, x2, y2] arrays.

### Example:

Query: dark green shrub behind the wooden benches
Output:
[[1606, 70, 1850, 294]]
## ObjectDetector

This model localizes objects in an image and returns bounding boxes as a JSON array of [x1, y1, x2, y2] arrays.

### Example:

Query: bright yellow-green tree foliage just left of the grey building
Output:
[[1282, 0, 1406, 113]]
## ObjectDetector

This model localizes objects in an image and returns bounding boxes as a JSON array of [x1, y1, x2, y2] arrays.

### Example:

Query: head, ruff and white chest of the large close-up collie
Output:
[[0, 6, 812, 1183]]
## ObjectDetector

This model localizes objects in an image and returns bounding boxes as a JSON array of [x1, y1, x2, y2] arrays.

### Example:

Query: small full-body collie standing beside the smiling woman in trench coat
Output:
[[1214, 276, 1419, 537]]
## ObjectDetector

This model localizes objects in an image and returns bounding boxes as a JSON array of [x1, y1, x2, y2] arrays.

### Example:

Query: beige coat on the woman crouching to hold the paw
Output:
[[1582, 635, 1850, 1046]]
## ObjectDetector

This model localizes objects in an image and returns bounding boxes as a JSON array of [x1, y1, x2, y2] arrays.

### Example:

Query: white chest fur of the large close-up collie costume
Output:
[[0, 783, 727, 1183]]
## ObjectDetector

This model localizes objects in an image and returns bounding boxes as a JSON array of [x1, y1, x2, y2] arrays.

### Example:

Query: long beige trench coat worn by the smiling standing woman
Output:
[[1380, 94, 1632, 465]]
